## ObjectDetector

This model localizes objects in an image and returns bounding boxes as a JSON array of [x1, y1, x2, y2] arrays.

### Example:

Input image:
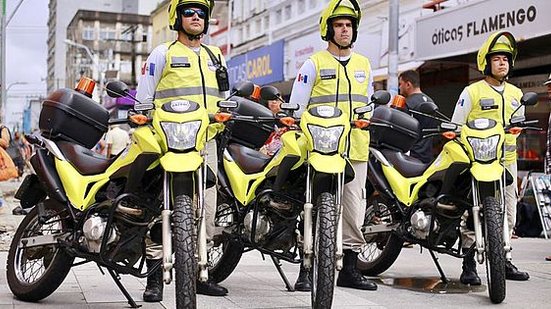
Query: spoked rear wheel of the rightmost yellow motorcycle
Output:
[[357, 203, 404, 276]]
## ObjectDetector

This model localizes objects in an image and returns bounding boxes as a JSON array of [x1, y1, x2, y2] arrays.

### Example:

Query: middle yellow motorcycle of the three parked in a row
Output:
[[207, 86, 390, 308]]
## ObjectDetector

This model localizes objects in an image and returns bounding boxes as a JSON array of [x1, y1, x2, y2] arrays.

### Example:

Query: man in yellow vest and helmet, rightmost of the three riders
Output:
[[452, 32, 530, 285]]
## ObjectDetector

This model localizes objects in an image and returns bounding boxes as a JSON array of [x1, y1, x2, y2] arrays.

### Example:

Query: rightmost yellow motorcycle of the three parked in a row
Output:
[[358, 93, 537, 303]]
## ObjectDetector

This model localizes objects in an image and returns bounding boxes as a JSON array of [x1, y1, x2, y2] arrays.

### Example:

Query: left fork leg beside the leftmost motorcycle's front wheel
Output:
[[161, 171, 174, 284]]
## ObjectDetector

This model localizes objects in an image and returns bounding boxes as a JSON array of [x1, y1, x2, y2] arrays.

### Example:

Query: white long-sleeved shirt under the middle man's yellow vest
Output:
[[289, 55, 373, 117]]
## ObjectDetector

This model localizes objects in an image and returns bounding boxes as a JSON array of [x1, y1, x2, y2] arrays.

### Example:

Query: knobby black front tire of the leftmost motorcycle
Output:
[[172, 195, 197, 309]]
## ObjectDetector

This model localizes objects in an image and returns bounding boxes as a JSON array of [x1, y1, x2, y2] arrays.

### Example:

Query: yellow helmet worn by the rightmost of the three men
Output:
[[476, 31, 518, 75]]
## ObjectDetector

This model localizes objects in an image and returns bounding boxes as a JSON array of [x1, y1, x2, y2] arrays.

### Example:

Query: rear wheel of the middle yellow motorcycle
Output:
[[208, 204, 244, 283]]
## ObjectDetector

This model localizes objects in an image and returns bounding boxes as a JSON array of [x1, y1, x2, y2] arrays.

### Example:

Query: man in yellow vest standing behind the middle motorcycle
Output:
[[289, 0, 377, 291]]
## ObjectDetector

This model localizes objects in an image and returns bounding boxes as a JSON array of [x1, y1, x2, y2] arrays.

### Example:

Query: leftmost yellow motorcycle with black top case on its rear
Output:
[[7, 81, 252, 308]]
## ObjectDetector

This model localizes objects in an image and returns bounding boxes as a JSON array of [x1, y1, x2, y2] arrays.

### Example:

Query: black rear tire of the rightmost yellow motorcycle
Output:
[[357, 202, 404, 276]]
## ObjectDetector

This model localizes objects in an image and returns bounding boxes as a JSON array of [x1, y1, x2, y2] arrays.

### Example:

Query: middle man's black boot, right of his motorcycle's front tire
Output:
[[337, 250, 377, 291]]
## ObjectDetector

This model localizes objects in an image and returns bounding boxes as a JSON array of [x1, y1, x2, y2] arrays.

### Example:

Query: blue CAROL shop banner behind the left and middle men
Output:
[[227, 40, 284, 86]]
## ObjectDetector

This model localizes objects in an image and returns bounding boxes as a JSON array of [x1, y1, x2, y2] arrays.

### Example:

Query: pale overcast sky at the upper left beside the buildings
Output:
[[6, 0, 48, 125]]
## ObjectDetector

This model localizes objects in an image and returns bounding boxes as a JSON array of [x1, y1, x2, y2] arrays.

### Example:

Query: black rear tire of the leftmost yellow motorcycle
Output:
[[6, 201, 74, 302]]
